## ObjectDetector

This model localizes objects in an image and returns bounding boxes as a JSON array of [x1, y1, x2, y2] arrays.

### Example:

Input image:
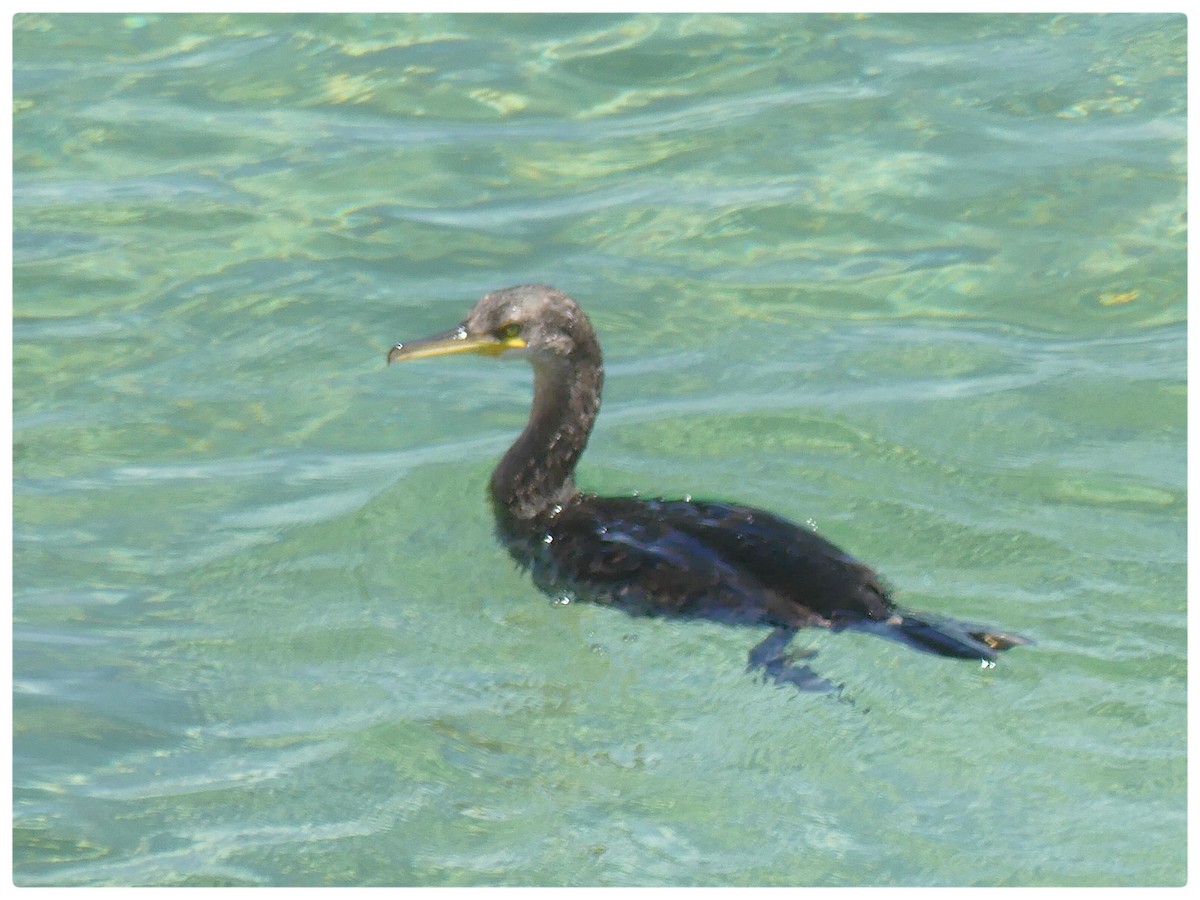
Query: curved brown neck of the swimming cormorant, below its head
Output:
[[492, 348, 604, 522]]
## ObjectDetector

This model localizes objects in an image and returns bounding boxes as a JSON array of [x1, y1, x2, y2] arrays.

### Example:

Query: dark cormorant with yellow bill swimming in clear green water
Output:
[[388, 284, 1030, 691]]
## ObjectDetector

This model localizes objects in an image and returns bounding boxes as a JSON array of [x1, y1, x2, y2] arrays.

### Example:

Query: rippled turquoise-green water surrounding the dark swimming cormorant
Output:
[[13, 14, 1187, 886]]
